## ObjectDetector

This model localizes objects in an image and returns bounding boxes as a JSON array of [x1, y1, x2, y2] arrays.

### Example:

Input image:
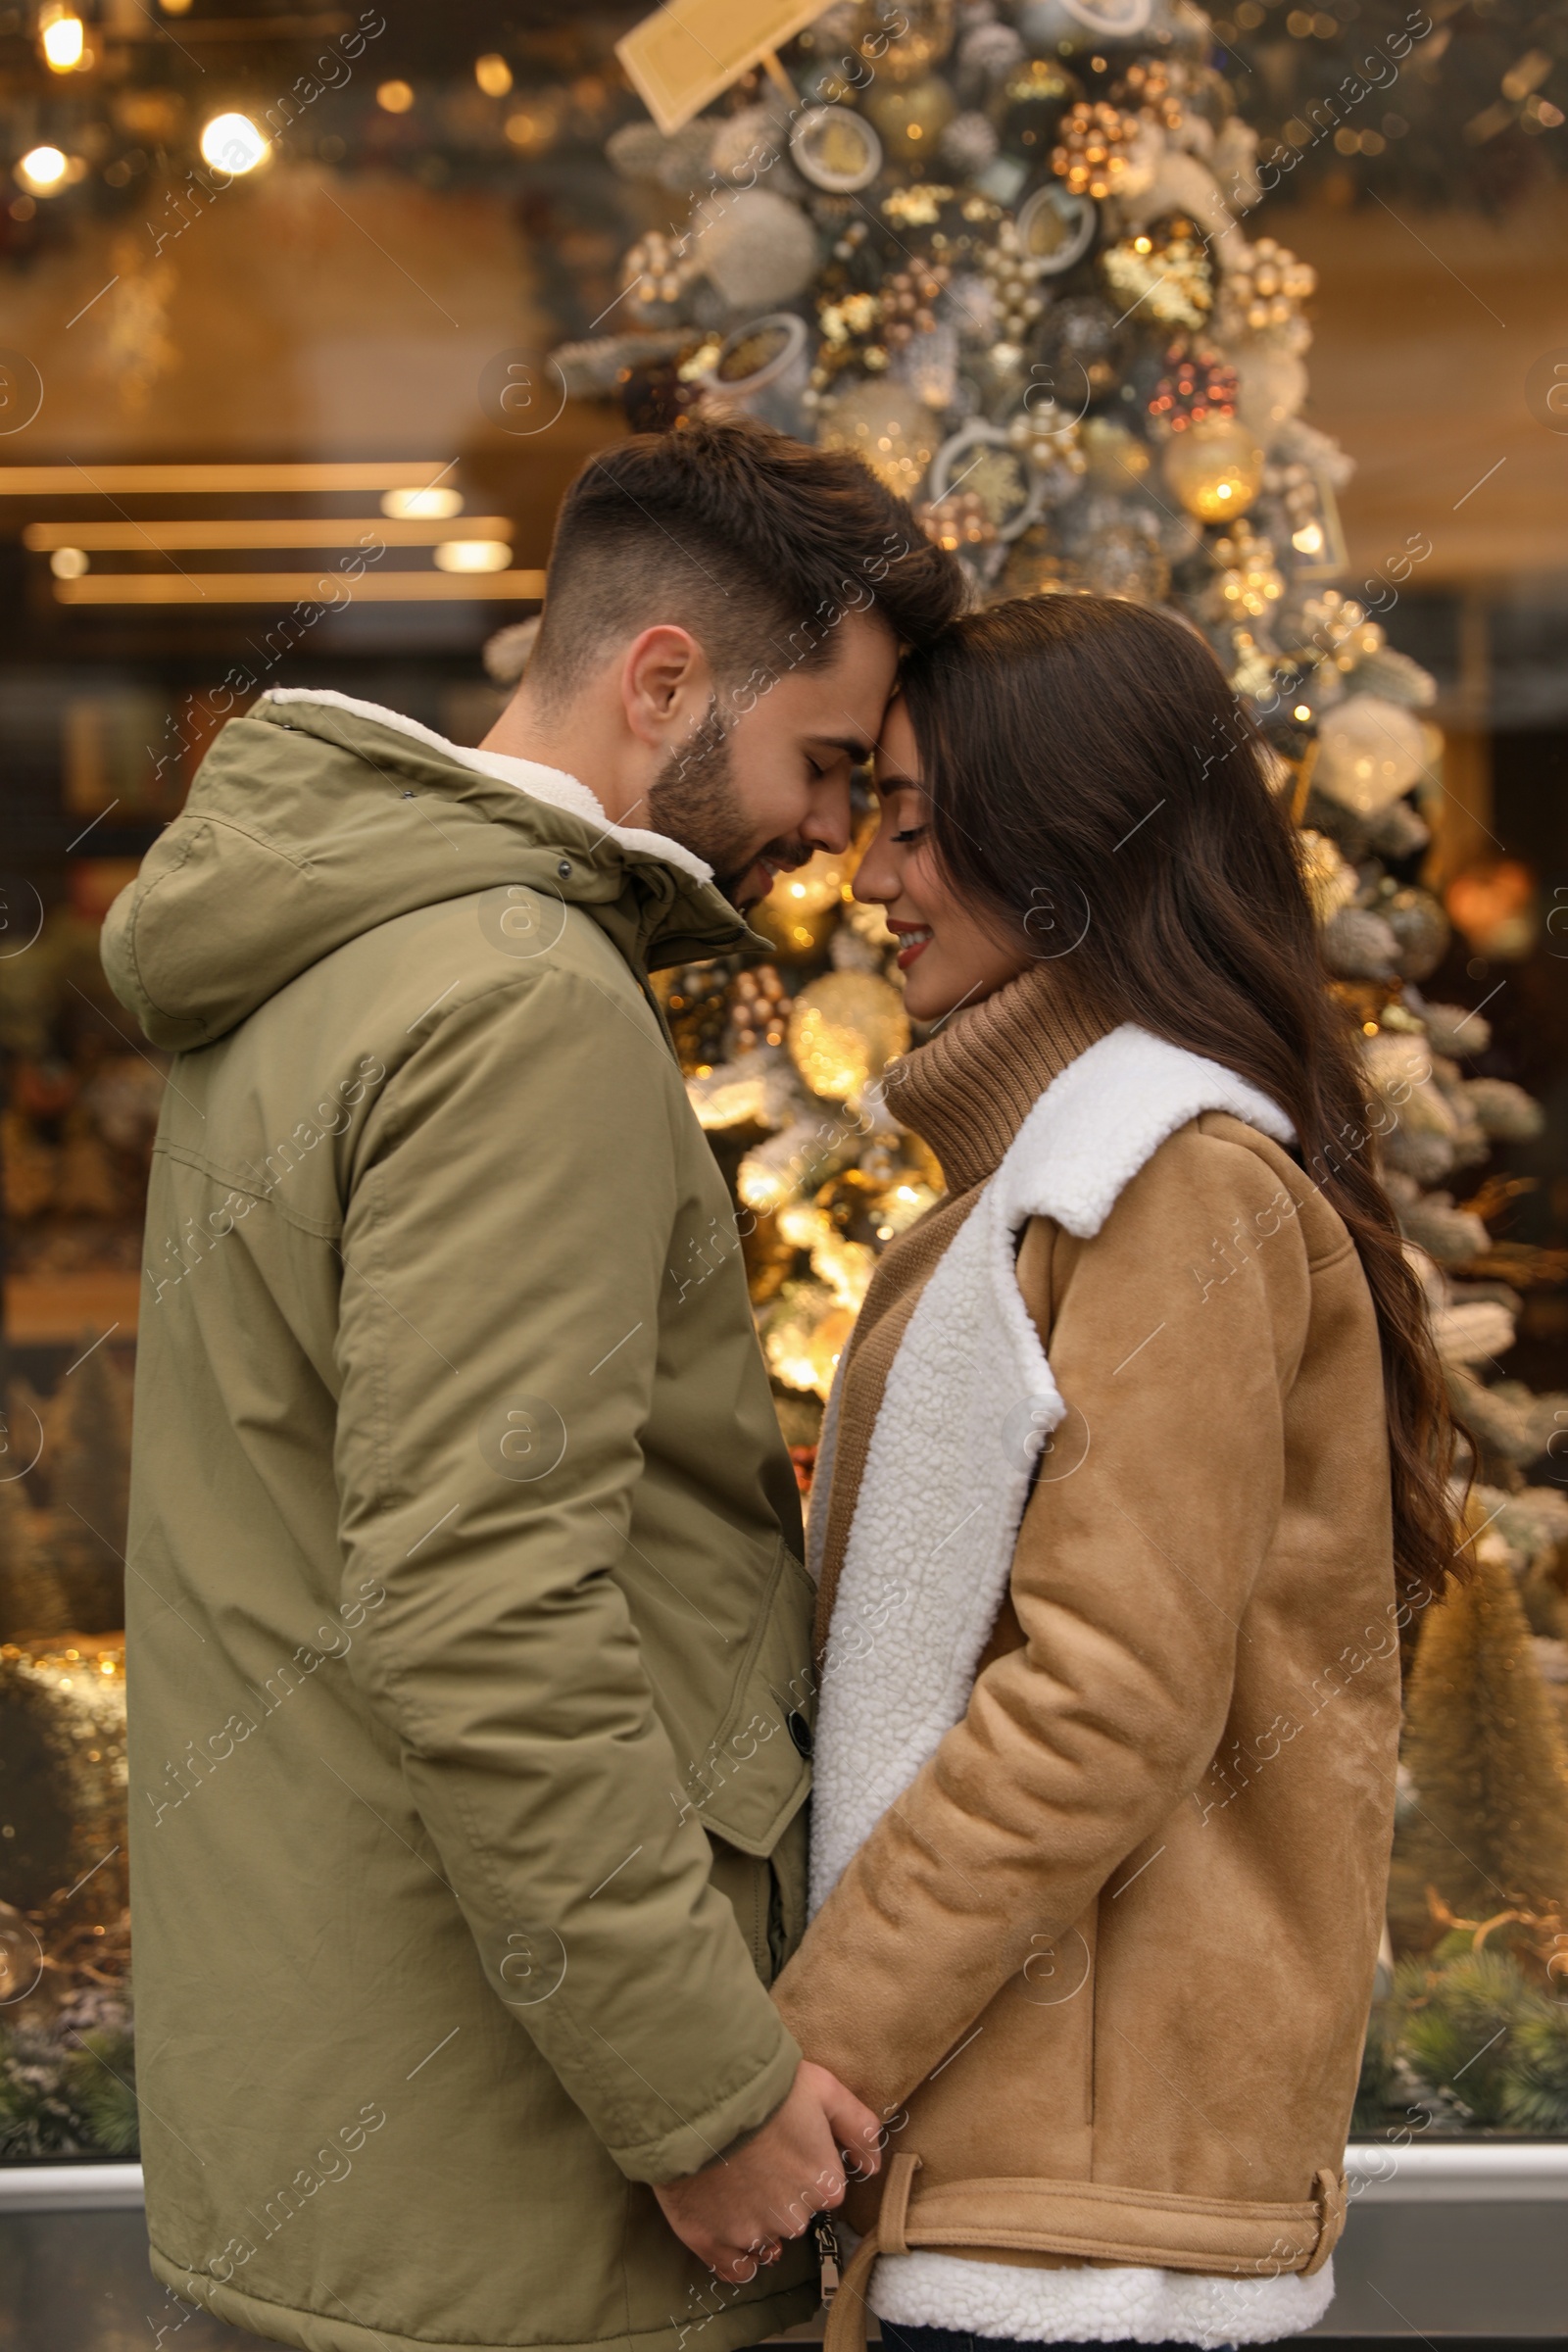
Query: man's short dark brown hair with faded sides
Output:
[[529, 418, 966, 699]]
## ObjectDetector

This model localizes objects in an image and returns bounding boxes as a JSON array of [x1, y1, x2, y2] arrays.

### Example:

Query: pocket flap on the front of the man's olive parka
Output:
[[689, 1543, 815, 1858]]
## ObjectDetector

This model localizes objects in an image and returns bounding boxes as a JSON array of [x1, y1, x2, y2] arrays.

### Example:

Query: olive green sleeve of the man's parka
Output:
[[336, 966, 800, 2180]]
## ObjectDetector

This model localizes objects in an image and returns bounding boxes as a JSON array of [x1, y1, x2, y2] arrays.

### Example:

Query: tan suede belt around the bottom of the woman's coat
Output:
[[823, 2150, 1348, 2352]]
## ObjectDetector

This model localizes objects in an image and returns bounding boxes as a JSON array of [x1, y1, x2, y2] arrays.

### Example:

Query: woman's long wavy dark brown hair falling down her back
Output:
[[903, 595, 1464, 1609]]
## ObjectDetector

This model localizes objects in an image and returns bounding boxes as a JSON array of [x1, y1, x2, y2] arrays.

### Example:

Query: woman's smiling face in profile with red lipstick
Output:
[[856, 701, 1032, 1021]]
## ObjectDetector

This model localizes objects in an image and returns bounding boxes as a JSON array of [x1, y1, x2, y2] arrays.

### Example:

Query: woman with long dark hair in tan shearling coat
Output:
[[776, 598, 1452, 2352]]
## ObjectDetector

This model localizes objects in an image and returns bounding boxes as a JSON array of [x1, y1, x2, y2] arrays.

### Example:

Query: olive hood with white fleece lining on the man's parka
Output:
[[104, 689, 761, 1052]]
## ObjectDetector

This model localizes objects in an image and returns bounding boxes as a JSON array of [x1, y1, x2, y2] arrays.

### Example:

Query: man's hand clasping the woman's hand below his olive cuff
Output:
[[654, 2058, 882, 2281]]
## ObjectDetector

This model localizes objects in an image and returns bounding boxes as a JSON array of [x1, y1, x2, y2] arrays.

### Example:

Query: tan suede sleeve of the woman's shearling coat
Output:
[[773, 1124, 1309, 2115]]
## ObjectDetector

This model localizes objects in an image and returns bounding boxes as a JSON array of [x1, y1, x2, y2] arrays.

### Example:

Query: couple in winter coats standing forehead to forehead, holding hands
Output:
[[106, 421, 1450, 2352]]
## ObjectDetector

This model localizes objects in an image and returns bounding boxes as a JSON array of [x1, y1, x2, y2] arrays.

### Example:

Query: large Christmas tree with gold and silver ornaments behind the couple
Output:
[[543, 0, 1568, 2129]]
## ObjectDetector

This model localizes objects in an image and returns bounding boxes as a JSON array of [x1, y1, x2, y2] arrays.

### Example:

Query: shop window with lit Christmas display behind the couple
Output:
[[0, 0, 1568, 2164]]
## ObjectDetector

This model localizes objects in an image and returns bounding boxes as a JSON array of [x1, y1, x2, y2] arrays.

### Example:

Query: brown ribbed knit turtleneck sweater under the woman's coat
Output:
[[811, 964, 1112, 1653]]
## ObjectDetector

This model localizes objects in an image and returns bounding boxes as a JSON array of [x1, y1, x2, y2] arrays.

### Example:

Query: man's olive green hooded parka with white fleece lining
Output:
[[104, 694, 815, 2352]]
